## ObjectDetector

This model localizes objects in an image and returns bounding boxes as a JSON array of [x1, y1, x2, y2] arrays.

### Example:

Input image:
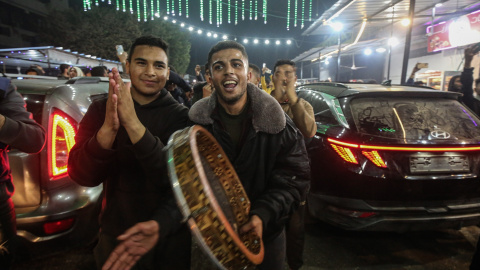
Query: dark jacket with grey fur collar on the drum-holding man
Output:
[[189, 83, 310, 241]]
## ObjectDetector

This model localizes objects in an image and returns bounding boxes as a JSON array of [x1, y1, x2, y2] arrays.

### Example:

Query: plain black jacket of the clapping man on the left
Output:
[[68, 89, 188, 237]]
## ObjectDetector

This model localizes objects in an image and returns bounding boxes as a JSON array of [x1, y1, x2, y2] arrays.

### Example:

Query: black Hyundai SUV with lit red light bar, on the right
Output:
[[297, 83, 480, 231]]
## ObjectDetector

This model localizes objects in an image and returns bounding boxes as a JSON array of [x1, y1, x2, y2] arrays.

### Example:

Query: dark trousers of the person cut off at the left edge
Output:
[[0, 195, 17, 269]]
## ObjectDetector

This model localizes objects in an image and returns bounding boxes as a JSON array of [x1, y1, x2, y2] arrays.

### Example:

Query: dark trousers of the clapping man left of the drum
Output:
[[93, 225, 191, 270]]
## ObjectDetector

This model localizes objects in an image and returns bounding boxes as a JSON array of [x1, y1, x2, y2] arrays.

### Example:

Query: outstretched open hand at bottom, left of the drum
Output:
[[102, 220, 160, 270]]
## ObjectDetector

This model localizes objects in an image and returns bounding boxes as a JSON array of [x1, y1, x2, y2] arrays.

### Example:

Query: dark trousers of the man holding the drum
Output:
[[257, 230, 286, 270]]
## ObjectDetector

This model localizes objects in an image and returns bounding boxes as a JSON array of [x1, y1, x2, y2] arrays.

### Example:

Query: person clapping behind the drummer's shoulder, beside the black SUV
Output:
[[271, 60, 317, 270]]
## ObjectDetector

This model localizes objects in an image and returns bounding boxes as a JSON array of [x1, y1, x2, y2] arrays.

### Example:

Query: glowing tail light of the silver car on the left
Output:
[[48, 109, 77, 180]]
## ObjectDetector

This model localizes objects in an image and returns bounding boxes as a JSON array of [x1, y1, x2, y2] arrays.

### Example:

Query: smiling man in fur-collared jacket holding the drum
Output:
[[102, 41, 310, 270]]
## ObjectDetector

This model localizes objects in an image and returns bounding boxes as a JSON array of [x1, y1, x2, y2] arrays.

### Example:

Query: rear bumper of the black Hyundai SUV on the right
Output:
[[308, 193, 480, 232]]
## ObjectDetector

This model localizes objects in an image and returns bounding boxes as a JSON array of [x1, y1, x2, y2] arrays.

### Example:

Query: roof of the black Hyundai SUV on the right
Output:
[[297, 82, 461, 99]]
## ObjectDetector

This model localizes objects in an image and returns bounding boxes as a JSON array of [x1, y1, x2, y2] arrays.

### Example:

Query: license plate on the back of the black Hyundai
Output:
[[410, 156, 470, 173]]
